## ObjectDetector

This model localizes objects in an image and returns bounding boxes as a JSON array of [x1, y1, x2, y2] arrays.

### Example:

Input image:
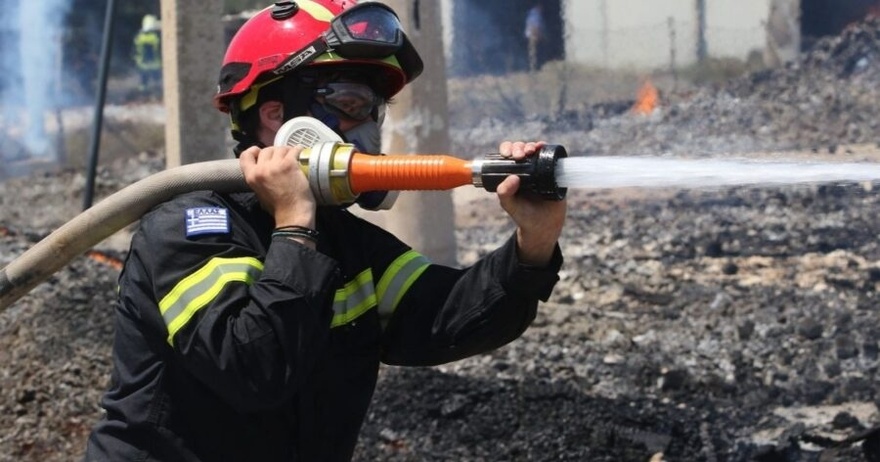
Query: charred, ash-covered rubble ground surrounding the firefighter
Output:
[[0, 19, 880, 462]]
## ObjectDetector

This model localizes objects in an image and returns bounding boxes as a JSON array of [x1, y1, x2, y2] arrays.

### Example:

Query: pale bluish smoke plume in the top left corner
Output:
[[0, 0, 71, 159]]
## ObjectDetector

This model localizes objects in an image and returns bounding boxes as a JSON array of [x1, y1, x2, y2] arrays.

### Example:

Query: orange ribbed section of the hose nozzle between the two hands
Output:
[[348, 153, 473, 194]]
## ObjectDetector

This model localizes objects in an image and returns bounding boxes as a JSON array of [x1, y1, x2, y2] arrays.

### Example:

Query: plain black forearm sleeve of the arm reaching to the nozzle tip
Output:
[[382, 233, 562, 365]]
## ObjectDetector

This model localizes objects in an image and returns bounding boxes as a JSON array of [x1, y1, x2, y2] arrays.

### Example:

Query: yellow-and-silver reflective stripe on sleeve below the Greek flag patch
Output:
[[159, 257, 263, 345]]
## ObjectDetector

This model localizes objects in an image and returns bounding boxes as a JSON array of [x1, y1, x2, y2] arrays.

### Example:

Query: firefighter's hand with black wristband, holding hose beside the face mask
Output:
[[238, 146, 317, 229]]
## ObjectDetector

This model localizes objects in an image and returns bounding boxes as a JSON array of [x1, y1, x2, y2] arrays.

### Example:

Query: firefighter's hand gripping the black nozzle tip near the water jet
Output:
[[497, 141, 566, 266]]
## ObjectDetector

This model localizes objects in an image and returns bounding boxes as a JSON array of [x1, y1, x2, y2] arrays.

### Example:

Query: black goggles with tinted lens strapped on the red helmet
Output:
[[273, 2, 424, 80]]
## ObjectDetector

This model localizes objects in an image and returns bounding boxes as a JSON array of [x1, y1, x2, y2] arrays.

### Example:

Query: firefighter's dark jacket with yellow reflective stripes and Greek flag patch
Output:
[[85, 192, 562, 462]]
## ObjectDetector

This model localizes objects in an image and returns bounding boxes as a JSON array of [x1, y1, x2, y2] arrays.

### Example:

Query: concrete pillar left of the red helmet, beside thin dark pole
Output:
[[161, 0, 232, 168]]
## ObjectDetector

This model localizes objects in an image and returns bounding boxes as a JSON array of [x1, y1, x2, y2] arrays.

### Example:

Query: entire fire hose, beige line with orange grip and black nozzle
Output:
[[0, 141, 567, 311]]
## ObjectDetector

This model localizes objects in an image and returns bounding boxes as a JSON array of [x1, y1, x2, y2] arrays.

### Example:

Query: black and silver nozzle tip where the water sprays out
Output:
[[473, 144, 568, 201]]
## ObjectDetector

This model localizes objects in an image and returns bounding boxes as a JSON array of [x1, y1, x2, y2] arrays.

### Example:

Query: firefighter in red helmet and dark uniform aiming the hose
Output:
[[85, 0, 566, 462]]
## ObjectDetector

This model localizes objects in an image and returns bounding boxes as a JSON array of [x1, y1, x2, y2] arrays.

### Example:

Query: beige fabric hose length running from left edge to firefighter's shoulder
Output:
[[0, 159, 250, 311]]
